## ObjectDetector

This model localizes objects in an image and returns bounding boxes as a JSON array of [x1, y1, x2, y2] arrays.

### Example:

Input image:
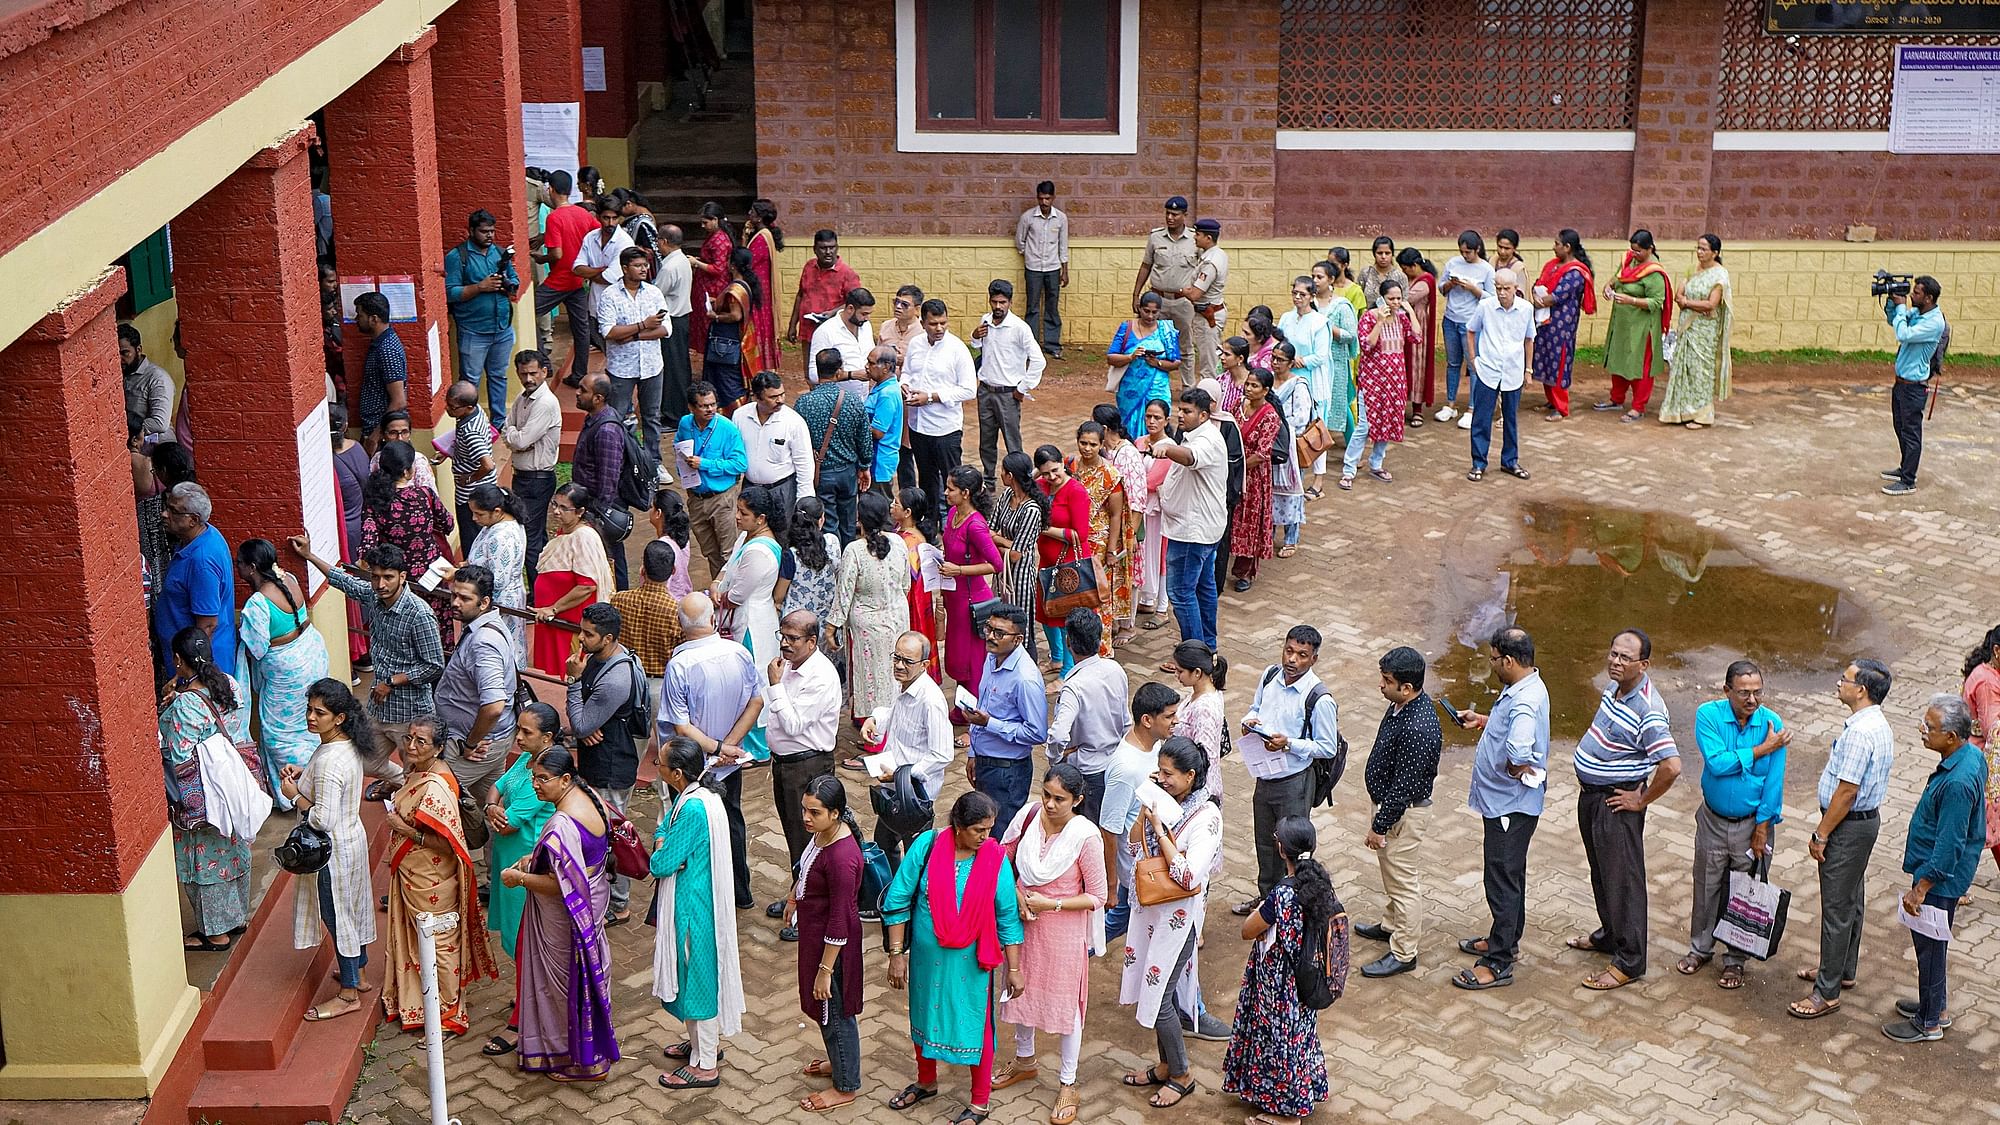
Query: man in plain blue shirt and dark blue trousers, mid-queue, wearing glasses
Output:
[[964, 605, 1048, 833]]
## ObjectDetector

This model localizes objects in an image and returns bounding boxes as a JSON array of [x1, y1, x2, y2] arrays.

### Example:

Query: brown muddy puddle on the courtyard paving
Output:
[[1434, 502, 1862, 736]]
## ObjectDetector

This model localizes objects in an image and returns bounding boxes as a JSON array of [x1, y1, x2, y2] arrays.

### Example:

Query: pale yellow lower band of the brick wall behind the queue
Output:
[[778, 234, 2000, 354]]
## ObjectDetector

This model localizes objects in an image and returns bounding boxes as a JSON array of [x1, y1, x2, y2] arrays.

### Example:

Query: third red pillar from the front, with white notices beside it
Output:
[[326, 28, 450, 430]]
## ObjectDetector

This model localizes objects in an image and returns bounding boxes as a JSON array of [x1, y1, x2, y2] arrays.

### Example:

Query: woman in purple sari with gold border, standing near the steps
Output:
[[500, 747, 618, 1083]]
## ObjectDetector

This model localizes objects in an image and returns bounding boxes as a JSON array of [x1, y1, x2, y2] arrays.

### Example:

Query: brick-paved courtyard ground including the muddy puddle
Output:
[[348, 362, 2000, 1125]]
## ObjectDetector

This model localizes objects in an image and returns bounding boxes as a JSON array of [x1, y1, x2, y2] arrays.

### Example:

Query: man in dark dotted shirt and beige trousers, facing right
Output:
[[1354, 647, 1444, 977]]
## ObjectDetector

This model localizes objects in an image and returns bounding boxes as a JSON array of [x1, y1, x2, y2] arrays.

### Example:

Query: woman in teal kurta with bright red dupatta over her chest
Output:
[[882, 791, 1024, 1121]]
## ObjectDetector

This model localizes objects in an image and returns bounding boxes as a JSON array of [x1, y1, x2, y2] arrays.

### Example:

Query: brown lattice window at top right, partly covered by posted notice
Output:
[[1716, 0, 2000, 132]]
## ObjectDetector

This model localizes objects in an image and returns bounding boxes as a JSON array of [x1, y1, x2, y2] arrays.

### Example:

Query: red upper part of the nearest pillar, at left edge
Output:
[[0, 264, 163, 892]]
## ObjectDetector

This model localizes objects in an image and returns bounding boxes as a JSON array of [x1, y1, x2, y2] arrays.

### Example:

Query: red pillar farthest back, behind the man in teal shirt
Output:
[[436, 0, 532, 256]]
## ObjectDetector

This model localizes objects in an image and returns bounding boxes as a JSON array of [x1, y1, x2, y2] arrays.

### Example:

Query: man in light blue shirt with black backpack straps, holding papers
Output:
[[1230, 625, 1340, 917]]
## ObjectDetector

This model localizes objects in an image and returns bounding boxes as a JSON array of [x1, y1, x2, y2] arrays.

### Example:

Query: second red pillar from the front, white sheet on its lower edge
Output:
[[174, 126, 346, 552]]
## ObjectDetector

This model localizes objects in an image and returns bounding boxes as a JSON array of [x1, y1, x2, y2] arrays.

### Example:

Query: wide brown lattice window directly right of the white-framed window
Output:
[[1278, 0, 1640, 130]]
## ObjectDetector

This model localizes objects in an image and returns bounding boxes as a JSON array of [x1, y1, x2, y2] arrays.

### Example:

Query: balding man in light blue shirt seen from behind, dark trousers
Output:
[[654, 593, 764, 911]]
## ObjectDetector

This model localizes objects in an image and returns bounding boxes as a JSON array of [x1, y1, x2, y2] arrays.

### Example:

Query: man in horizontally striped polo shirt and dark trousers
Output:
[[1568, 629, 1680, 991]]
